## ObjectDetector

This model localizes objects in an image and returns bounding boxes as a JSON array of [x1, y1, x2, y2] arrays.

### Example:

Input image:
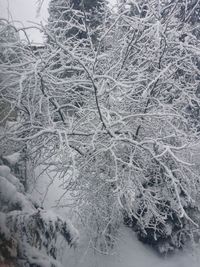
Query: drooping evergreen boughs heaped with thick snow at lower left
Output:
[[0, 165, 78, 267]]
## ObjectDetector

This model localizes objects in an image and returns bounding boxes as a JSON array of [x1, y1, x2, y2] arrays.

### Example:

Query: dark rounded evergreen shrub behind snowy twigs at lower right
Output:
[[124, 154, 200, 254]]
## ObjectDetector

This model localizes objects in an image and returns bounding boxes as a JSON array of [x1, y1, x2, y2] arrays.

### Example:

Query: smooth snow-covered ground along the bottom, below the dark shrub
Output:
[[62, 227, 200, 267]]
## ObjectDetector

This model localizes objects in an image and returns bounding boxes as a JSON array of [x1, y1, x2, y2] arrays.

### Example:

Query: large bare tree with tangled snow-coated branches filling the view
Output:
[[1, 0, 200, 258]]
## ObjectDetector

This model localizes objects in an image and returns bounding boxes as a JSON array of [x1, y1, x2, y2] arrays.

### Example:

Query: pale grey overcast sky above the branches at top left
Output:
[[0, 0, 116, 43]]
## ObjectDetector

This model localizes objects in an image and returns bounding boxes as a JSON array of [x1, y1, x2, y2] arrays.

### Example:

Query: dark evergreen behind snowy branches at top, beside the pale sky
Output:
[[48, 0, 106, 42]]
